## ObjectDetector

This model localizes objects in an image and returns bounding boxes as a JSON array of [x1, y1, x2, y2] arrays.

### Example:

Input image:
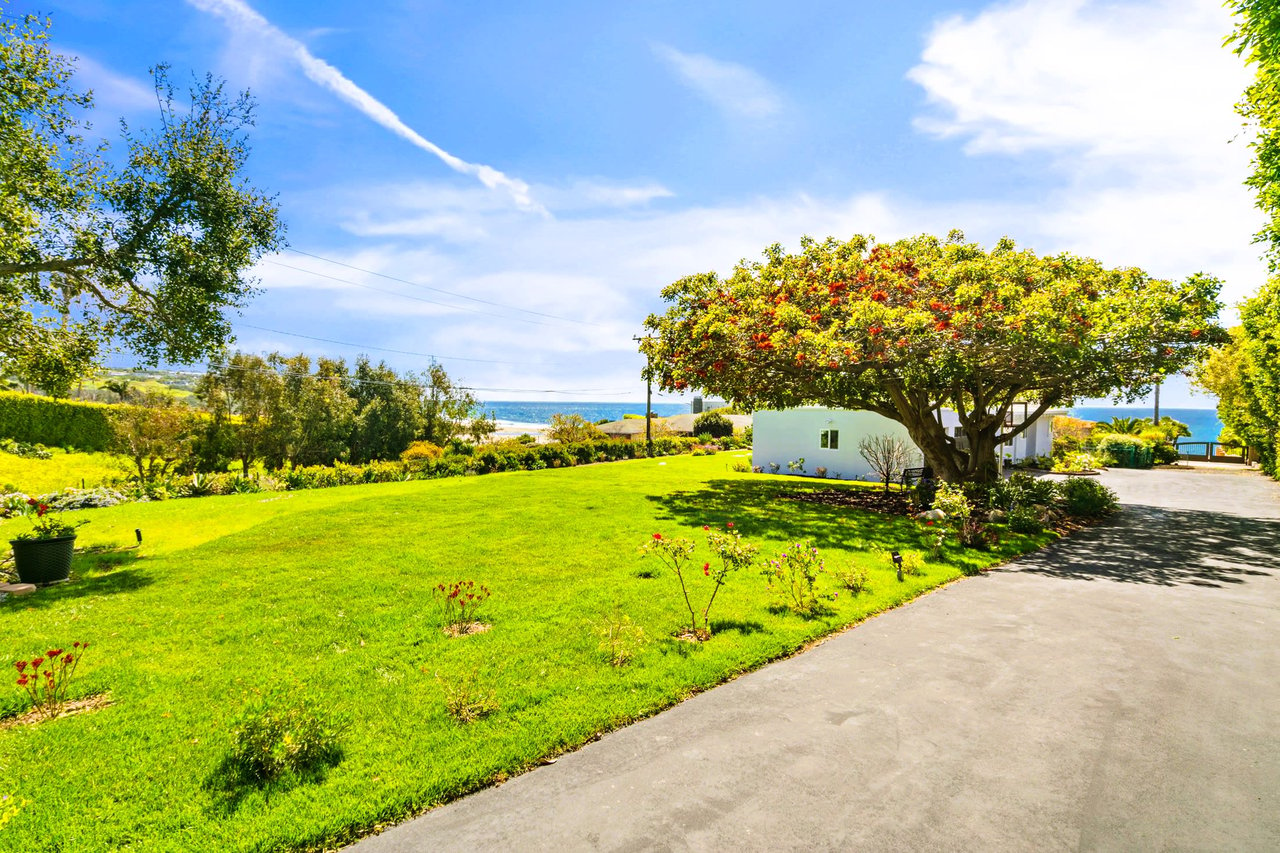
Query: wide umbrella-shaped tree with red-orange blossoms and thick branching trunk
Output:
[[641, 231, 1225, 482]]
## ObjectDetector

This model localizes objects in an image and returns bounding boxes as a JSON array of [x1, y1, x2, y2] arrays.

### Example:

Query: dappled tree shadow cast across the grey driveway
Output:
[[1006, 505, 1280, 588]]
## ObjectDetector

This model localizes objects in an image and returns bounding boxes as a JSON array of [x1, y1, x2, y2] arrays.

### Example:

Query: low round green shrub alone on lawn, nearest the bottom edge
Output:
[[223, 698, 346, 783]]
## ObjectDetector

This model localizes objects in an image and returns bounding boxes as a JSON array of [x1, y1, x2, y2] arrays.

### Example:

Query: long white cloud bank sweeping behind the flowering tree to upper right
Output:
[[235, 0, 1265, 400]]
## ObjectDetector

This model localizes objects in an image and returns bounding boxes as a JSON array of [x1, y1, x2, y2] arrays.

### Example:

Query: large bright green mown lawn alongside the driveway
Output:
[[0, 452, 1043, 850]]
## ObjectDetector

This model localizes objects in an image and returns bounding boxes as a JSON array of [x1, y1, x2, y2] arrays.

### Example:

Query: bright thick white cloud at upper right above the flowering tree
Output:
[[908, 0, 1265, 312]]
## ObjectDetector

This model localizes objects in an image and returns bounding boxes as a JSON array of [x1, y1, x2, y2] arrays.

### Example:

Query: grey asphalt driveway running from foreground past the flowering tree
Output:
[[353, 470, 1280, 853]]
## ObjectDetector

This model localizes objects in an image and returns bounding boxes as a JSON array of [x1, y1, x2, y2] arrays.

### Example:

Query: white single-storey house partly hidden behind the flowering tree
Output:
[[751, 403, 1066, 480]]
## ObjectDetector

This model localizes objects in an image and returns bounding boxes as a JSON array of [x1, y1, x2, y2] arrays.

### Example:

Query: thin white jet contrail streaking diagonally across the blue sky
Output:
[[187, 0, 547, 214]]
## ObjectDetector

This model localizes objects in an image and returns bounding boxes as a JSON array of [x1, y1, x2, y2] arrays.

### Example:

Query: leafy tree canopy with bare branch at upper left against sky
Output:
[[0, 8, 284, 392]]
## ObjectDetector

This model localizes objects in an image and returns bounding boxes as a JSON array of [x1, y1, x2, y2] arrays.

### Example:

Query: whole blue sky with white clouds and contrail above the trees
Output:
[[9, 0, 1265, 406]]
